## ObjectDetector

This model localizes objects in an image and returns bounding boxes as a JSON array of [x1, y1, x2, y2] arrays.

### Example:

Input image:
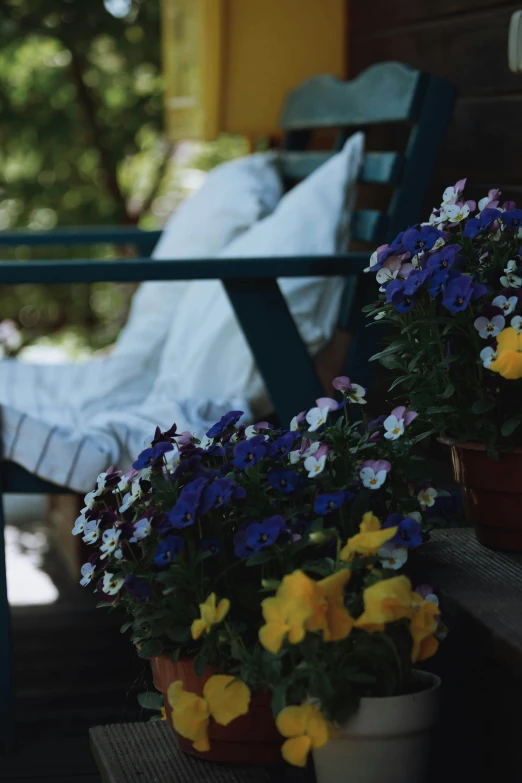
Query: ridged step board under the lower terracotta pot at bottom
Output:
[[90, 721, 270, 783]]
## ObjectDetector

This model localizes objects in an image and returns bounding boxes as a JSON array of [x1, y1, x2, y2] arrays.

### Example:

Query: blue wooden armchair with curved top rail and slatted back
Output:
[[0, 63, 455, 748]]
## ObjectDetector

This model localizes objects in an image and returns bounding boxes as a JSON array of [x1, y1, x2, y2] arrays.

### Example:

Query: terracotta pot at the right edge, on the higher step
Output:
[[443, 440, 522, 551]]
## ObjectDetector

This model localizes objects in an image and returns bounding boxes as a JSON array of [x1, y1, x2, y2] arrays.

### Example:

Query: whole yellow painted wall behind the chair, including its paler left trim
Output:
[[158, 0, 348, 140]]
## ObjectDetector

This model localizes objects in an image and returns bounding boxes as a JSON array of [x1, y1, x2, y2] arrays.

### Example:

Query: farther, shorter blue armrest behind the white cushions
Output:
[[0, 226, 162, 247]]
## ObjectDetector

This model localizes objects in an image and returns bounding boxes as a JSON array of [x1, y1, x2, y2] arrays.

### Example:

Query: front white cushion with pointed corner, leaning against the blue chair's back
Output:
[[151, 133, 364, 426]]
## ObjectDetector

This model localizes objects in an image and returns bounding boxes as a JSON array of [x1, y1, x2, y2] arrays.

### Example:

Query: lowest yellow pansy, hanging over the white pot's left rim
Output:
[[276, 704, 330, 767]]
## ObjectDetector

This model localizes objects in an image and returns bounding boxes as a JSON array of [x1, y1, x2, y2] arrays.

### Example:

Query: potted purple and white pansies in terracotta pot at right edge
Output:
[[367, 179, 522, 550]]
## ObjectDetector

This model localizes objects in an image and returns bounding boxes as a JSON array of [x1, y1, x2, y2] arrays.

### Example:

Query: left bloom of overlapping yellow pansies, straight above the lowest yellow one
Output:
[[259, 596, 311, 655]]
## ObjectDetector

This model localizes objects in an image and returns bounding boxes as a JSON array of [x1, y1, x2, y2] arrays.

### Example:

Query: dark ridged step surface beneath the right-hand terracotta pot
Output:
[[416, 528, 522, 675]]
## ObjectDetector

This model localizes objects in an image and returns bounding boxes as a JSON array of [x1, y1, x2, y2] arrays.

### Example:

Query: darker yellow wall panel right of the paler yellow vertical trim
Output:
[[221, 0, 347, 134]]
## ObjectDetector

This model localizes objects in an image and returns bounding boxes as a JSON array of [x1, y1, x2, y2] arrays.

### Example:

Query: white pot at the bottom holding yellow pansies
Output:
[[313, 672, 440, 783]]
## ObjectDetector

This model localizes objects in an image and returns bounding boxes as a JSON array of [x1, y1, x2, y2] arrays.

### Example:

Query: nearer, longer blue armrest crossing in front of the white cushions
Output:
[[0, 253, 369, 285]]
